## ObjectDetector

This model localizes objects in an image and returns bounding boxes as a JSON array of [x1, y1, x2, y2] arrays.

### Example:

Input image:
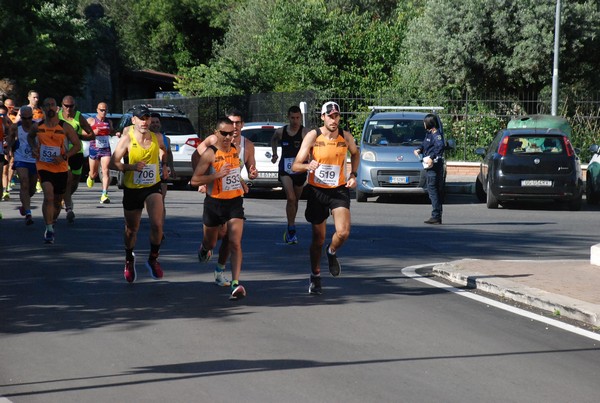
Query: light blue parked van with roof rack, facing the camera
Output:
[[356, 106, 454, 202]]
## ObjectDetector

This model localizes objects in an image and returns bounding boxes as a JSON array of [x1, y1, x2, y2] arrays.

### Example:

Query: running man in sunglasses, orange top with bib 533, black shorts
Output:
[[191, 117, 246, 300]]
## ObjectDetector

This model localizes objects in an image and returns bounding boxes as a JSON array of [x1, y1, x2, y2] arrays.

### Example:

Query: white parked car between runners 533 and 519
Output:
[[242, 122, 285, 189]]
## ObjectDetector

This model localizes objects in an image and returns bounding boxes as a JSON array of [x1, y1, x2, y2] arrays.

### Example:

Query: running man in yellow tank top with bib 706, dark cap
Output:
[[109, 105, 168, 283]]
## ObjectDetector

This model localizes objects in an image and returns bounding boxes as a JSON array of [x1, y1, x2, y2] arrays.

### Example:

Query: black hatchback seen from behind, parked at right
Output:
[[475, 123, 583, 210]]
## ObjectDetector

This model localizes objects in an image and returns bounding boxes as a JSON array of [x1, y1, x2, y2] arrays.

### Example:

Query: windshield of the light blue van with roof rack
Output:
[[363, 120, 425, 146]]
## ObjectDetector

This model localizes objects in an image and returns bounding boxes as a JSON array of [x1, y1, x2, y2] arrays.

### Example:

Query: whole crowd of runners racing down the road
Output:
[[0, 97, 359, 300]]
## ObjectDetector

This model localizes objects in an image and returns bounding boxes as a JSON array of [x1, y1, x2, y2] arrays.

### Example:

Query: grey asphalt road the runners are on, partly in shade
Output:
[[0, 188, 600, 402]]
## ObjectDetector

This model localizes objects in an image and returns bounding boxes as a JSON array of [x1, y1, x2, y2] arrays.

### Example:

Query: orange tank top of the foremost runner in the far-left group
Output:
[[36, 122, 69, 173]]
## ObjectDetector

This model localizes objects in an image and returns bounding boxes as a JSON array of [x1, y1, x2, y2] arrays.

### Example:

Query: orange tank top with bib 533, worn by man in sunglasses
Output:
[[207, 144, 244, 199]]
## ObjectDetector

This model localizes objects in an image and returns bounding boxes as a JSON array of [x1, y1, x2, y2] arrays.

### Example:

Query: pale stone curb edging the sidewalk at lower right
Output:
[[432, 263, 600, 326]]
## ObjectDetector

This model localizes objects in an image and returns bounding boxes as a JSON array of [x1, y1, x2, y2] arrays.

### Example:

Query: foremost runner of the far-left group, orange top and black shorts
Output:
[[27, 98, 81, 243]]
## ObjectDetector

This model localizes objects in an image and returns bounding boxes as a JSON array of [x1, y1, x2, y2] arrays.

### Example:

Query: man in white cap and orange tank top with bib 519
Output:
[[292, 102, 359, 294]]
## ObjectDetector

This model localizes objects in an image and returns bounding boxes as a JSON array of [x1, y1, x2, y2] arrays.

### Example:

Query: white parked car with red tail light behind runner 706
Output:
[[111, 105, 197, 185]]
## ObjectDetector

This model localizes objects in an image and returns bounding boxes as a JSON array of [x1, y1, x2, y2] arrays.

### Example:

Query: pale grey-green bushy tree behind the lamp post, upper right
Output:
[[396, 0, 600, 94]]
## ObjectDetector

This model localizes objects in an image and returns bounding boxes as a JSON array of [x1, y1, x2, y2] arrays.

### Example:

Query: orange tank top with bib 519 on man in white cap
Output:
[[308, 129, 348, 188]]
